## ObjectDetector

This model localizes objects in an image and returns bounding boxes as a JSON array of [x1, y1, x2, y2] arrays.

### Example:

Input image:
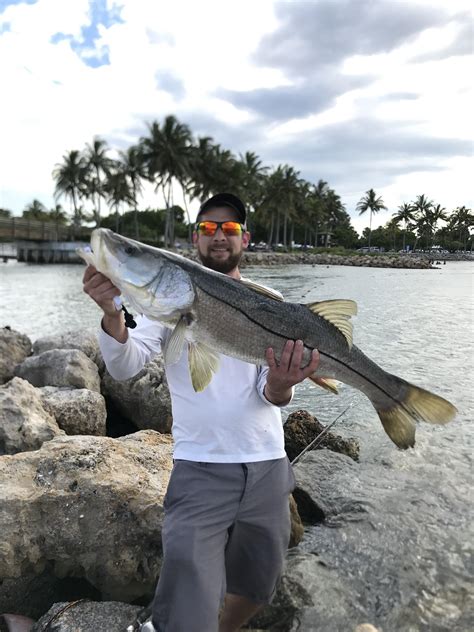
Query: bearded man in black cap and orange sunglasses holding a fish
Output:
[[84, 193, 319, 632]]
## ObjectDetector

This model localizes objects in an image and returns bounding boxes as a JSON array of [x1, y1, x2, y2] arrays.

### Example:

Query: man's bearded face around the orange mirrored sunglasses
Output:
[[193, 208, 250, 274]]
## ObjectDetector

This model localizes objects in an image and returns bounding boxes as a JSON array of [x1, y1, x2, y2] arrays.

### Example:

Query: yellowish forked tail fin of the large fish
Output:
[[376, 382, 457, 449]]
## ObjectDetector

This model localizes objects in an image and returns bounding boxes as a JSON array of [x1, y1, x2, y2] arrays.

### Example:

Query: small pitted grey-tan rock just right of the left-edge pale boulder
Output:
[[39, 386, 107, 436]]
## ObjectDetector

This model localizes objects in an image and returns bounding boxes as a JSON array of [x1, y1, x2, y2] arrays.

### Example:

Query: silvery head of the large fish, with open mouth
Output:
[[91, 228, 194, 320]]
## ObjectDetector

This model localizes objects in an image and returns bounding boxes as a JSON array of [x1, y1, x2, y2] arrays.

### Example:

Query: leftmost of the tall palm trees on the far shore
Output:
[[53, 149, 87, 228]]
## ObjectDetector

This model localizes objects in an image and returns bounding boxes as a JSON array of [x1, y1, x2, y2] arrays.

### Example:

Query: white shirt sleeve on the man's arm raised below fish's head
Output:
[[99, 316, 167, 381]]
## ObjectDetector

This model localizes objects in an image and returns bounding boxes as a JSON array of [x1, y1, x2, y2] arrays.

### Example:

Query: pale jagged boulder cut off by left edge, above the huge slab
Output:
[[0, 377, 64, 454]]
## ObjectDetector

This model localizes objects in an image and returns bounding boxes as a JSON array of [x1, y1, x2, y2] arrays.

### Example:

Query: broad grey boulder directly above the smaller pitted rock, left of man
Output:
[[15, 349, 100, 393]]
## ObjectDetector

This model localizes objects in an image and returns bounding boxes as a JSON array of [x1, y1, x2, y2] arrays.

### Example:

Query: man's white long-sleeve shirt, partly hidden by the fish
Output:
[[99, 316, 285, 463]]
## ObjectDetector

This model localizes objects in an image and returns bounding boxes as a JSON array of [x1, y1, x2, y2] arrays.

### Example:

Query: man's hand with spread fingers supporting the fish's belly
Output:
[[264, 340, 319, 405]]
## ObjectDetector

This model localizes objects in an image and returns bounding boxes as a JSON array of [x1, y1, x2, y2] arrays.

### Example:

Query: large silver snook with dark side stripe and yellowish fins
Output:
[[82, 228, 457, 448]]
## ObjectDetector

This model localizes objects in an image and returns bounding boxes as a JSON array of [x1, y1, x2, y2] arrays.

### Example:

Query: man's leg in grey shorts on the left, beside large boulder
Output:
[[152, 461, 245, 632]]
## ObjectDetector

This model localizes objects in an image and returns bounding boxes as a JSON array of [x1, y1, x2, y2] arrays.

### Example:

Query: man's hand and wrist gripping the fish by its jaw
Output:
[[82, 266, 128, 343]]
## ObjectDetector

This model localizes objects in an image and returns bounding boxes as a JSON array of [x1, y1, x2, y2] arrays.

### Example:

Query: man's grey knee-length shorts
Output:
[[153, 457, 295, 632]]
